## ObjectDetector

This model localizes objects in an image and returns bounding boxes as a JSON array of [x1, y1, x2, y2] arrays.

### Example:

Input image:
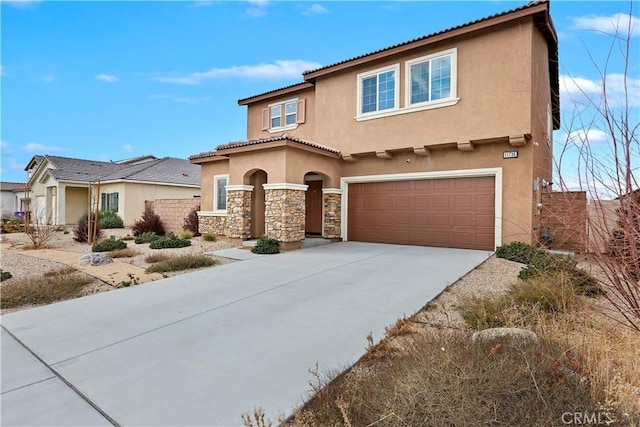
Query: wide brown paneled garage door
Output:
[[347, 177, 495, 250]]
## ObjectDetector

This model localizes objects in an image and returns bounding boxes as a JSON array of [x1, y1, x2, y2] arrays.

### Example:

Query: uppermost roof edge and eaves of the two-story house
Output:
[[238, 0, 560, 129]]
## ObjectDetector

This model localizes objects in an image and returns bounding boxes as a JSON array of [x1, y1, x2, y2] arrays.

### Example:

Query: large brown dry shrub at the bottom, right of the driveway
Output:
[[276, 330, 596, 426]]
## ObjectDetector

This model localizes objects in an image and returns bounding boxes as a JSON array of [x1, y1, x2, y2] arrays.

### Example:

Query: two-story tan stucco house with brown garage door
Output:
[[190, 2, 560, 250]]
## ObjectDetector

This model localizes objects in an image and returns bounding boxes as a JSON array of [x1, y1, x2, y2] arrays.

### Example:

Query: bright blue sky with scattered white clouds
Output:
[[0, 0, 640, 189]]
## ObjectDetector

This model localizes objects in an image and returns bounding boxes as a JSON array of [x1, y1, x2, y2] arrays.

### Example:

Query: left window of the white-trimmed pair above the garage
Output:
[[357, 64, 399, 116]]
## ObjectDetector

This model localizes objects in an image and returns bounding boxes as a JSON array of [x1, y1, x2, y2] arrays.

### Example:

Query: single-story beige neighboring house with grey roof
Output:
[[25, 155, 200, 226]]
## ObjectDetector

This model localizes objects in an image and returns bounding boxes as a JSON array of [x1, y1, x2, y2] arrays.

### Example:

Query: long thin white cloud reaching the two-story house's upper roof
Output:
[[153, 60, 320, 85]]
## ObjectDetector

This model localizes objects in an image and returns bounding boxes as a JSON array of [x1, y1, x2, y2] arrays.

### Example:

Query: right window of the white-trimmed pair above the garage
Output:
[[406, 49, 457, 107]]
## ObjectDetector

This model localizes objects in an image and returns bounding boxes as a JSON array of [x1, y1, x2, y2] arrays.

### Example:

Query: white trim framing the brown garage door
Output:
[[340, 168, 502, 248]]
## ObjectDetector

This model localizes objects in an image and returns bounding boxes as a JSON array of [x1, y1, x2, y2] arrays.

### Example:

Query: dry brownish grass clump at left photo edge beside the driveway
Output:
[[0, 268, 93, 309]]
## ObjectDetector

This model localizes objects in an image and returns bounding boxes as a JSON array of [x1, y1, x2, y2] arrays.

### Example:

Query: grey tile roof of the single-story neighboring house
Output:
[[33, 156, 200, 186]]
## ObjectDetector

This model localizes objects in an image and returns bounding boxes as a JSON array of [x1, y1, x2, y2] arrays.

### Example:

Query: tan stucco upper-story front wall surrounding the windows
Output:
[[248, 22, 546, 154]]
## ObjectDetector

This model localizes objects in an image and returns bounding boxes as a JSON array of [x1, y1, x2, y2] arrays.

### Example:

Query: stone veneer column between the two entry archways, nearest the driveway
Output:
[[263, 183, 308, 243]]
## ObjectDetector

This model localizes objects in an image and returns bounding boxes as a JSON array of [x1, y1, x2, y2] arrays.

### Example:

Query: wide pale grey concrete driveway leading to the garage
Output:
[[1, 242, 490, 426]]
